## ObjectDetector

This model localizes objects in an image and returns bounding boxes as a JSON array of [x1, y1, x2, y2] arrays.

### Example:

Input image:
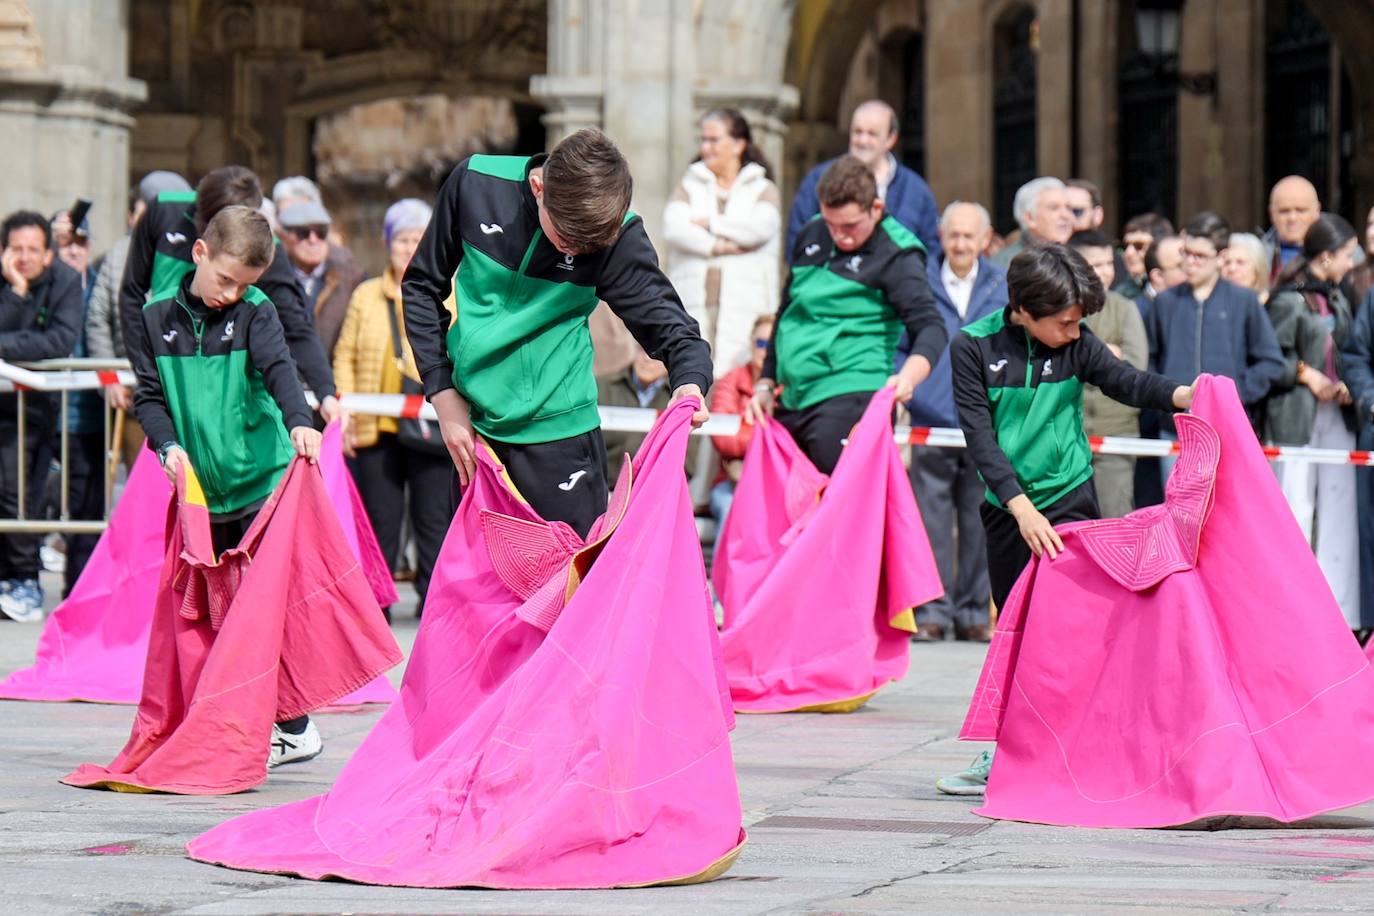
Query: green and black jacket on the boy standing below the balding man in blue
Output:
[[763, 216, 949, 411]]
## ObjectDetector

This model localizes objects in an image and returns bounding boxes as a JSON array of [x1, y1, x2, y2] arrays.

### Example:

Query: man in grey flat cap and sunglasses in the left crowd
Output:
[[276, 201, 363, 358]]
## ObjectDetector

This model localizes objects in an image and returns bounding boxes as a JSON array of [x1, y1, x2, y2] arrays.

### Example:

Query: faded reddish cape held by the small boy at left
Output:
[[62, 459, 403, 795]]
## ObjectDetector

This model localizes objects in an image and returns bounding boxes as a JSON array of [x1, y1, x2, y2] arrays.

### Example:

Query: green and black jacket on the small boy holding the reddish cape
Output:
[[125, 273, 311, 518]]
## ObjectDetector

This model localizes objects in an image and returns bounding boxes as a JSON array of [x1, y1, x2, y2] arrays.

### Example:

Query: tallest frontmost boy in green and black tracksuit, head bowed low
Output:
[[401, 129, 712, 536]]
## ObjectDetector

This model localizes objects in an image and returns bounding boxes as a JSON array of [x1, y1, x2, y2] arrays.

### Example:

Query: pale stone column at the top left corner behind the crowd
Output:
[[0, 0, 146, 251]]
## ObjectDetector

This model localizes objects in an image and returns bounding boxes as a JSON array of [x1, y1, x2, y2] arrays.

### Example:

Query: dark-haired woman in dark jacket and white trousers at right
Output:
[[1264, 213, 1363, 630]]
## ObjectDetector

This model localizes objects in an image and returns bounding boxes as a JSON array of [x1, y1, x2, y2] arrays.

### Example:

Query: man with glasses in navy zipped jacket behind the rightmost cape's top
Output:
[[1145, 211, 1283, 481]]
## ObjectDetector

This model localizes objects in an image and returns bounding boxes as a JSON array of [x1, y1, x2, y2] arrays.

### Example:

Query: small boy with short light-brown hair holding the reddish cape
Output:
[[126, 206, 323, 766]]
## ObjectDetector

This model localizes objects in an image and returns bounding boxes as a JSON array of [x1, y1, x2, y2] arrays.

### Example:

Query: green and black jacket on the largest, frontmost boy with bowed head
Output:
[[401, 155, 712, 445]]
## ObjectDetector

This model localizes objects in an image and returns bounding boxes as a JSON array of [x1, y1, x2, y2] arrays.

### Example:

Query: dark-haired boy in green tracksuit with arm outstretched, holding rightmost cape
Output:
[[936, 244, 1193, 795]]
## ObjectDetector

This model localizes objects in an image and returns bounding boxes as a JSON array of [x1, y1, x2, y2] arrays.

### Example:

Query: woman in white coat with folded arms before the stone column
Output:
[[664, 108, 782, 379]]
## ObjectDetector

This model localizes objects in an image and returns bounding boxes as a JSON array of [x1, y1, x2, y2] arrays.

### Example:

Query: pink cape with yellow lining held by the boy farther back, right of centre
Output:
[[713, 389, 944, 713]]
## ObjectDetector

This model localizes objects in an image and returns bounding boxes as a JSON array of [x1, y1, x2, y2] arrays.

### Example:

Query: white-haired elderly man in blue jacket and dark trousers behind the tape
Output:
[[896, 201, 1007, 643]]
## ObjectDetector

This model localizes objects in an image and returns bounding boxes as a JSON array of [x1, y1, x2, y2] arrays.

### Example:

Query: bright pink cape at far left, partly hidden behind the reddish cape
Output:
[[0, 423, 397, 706]]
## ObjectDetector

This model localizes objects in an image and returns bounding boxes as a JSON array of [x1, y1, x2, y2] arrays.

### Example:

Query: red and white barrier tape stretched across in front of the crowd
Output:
[[0, 360, 1374, 467]]
